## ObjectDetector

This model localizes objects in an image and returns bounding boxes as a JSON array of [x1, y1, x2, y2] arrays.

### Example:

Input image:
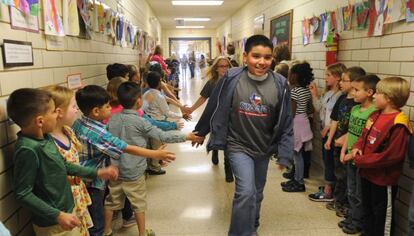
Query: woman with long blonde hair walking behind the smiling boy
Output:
[[190, 56, 234, 183]]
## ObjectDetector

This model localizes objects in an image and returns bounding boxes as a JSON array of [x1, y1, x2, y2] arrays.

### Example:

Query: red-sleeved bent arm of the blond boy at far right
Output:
[[354, 125, 408, 169]]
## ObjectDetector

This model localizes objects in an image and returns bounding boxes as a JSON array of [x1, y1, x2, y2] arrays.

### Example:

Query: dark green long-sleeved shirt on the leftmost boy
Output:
[[13, 132, 96, 227]]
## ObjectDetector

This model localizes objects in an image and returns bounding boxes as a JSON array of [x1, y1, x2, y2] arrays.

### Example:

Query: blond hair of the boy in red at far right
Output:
[[377, 77, 410, 108]]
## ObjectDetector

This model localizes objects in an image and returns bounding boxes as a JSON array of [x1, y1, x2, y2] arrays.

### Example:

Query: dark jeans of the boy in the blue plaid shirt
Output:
[[88, 188, 105, 236]]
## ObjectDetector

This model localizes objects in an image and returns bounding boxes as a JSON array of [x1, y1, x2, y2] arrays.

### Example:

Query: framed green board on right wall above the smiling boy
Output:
[[270, 9, 293, 51]]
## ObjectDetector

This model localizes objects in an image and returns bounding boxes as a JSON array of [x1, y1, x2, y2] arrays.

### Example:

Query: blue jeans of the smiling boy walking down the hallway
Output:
[[227, 151, 269, 236]]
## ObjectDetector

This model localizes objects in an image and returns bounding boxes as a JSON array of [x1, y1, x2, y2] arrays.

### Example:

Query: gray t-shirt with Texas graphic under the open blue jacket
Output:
[[227, 72, 279, 157]]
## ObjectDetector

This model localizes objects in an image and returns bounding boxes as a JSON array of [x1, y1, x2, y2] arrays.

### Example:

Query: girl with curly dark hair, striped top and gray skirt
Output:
[[279, 62, 313, 192]]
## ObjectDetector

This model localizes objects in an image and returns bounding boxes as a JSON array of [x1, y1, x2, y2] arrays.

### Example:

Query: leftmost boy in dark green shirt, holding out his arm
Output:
[[7, 88, 118, 236]]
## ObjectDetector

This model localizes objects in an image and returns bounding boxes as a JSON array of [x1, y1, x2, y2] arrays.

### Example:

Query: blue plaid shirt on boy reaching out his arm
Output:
[[72, 116, 128, 189]]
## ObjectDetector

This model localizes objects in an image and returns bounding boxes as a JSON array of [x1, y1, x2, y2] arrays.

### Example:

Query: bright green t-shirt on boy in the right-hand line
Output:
[[348, 105, 376, 153]]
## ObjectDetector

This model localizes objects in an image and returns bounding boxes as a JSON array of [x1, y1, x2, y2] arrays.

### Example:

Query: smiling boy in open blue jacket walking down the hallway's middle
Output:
[[195, 35, 293, 236]]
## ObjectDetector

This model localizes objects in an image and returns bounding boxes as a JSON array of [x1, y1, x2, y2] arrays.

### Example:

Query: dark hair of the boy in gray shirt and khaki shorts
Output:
[[117, 81, 141, 109]]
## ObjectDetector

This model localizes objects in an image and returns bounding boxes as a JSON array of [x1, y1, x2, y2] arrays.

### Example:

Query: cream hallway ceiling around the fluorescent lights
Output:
[[147, 0, 249, 29]]
